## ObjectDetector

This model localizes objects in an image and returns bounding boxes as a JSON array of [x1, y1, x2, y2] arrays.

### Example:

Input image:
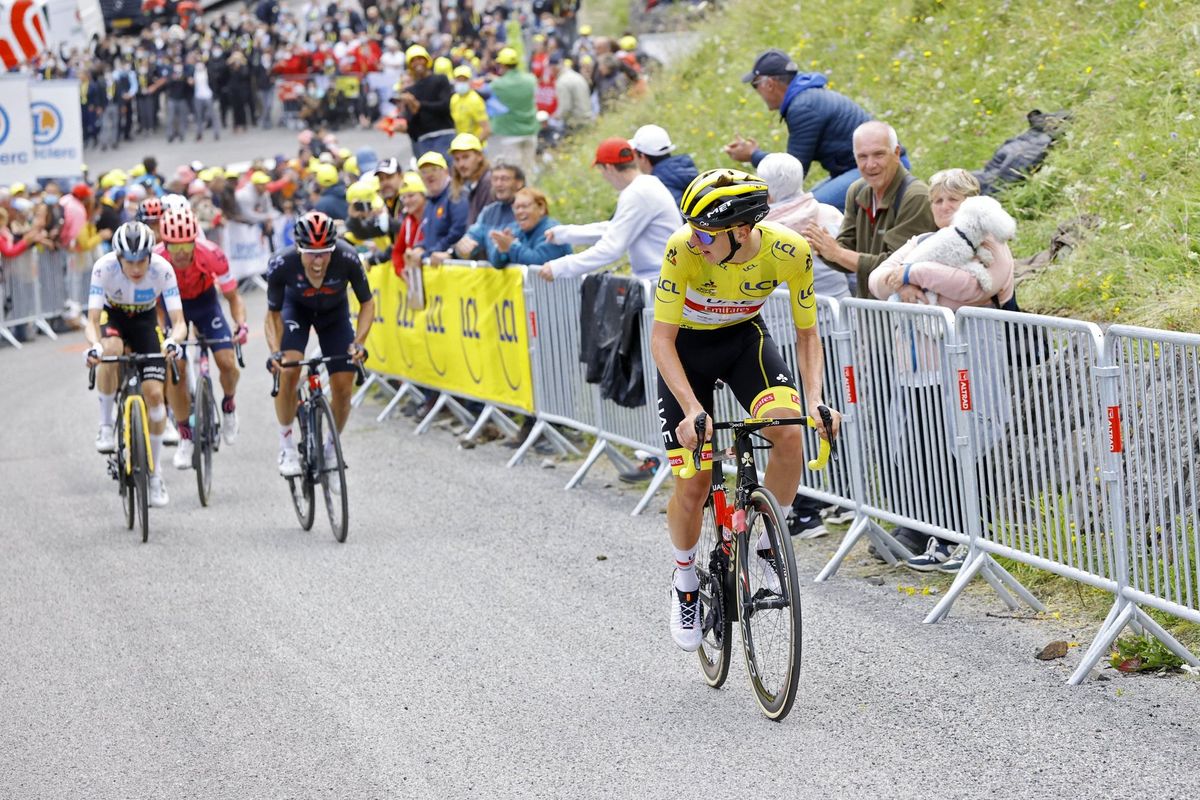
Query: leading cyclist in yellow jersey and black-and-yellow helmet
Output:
[[650, 169, 841, 650]]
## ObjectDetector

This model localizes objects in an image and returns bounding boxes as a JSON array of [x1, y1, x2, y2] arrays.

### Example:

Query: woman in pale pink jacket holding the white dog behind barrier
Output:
[[869, 169, 1015, 572]]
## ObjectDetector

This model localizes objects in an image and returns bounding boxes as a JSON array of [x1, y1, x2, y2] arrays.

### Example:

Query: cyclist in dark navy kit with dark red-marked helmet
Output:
[[263, 211, 374, 477]]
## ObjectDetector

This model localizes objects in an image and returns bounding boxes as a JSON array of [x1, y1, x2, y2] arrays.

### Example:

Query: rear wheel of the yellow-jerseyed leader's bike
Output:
[[696, 492, 736, 688]]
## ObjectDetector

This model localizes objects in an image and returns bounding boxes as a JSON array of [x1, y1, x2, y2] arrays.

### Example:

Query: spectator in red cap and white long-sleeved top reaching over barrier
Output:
[[539, 138, 683, 281]]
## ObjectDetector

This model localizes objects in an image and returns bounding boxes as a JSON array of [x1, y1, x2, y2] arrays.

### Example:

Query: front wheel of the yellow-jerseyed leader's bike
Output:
[[737, 488, 802, 721]]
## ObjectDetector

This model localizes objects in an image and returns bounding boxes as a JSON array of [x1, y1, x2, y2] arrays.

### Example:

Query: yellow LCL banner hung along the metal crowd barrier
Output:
[[367, 263, 533, 413]]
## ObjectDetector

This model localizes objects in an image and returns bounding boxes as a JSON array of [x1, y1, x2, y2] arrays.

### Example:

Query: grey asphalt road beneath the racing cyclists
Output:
[[0, 294, 1200, 799]]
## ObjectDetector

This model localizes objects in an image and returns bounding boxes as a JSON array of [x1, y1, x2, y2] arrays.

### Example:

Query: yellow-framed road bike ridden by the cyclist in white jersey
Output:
[[88, 353, 179, 542]]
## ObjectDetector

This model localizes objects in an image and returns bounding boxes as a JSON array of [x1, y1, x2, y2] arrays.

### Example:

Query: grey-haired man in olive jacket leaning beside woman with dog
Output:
[[804, 121, 937, 297]]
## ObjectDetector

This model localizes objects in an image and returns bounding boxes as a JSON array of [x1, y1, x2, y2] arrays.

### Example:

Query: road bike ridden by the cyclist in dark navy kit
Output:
[[271, 353, 366, 542]]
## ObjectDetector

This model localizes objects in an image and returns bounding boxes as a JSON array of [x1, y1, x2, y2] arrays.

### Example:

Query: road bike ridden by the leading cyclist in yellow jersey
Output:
[[680, 405, 836, 721]]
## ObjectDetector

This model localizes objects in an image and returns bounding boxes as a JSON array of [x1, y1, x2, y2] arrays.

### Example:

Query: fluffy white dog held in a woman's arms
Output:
[[905, 197, 1016, 293]]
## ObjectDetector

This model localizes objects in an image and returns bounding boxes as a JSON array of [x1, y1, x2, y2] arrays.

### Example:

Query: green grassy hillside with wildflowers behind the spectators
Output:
[[542, 0, 1200, 331]]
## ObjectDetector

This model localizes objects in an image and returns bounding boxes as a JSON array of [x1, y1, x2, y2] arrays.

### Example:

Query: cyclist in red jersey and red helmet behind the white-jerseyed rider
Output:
[[154, 207, 250, 469]]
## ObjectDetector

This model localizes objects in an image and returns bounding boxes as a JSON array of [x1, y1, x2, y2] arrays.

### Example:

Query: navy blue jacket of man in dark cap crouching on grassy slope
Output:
[[750, 72, 871, 178]]
